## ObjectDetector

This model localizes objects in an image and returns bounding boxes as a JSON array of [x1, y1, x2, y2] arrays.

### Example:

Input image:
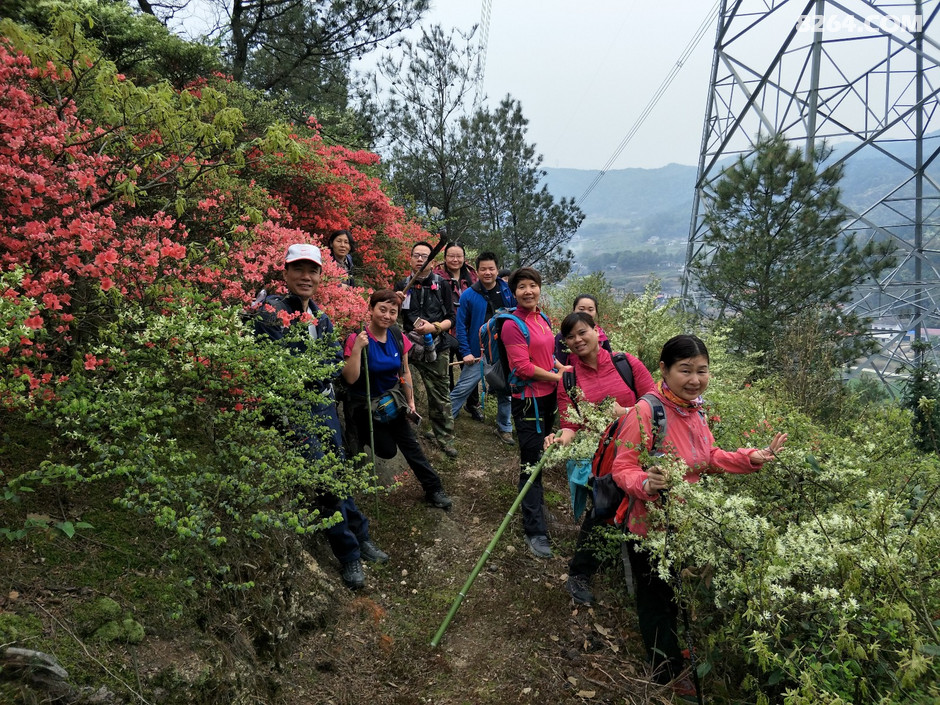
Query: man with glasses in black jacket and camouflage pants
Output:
[[395, 242, 457, 458]]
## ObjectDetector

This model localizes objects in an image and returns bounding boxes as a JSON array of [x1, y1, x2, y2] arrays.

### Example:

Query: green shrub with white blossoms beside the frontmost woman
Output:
[[556, 297, 940, 705]]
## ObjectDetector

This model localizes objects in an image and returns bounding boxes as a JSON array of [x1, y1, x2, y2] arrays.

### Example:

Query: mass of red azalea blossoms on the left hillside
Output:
[[0, 41, 426, 404]]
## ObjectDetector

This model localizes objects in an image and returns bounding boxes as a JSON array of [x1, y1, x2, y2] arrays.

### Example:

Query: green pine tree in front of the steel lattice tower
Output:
[[692, 135, 894, 364]]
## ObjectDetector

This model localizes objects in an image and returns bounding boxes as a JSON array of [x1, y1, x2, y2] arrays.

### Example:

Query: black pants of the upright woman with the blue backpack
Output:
[[512, 394, 557, 536]]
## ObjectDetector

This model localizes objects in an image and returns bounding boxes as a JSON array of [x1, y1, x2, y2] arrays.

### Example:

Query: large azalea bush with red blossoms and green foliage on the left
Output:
[[0, 13, 427, 586]]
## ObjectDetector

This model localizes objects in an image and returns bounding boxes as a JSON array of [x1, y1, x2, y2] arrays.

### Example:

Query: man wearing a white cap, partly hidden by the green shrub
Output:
[[255, 244, 388, 590]]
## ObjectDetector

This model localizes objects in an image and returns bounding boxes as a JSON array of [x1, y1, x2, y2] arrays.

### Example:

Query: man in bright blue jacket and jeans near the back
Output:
[[450, 252, 516, 445]]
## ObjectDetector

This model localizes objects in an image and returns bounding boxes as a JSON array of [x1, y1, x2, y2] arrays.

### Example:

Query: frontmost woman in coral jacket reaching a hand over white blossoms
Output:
[[611, 335, 787, 695]]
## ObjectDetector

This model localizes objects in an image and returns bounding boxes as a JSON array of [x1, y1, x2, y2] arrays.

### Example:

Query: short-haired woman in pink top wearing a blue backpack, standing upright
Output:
[[502, 267, 571, 558]]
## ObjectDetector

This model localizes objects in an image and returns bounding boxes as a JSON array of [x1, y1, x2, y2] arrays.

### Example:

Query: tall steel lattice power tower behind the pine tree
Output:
[[683, 0, 940, 380]]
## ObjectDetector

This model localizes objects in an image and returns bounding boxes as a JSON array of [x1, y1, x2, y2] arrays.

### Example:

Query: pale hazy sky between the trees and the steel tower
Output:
[[390, 0, 715, 169]]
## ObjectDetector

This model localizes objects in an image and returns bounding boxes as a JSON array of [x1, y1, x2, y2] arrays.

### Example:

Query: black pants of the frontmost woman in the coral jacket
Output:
[[627, 541, 683, 683]]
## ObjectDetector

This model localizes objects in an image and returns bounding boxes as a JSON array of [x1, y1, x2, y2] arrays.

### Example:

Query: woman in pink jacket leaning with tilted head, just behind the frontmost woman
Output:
[[545, 312, 656, 605]]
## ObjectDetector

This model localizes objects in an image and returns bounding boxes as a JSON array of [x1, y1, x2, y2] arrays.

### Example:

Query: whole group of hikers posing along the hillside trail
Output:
[[255, 230, 786, 695]]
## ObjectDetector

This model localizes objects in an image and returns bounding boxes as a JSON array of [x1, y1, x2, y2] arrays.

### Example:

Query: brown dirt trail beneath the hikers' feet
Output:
[[284, 412, 669, 705]]
